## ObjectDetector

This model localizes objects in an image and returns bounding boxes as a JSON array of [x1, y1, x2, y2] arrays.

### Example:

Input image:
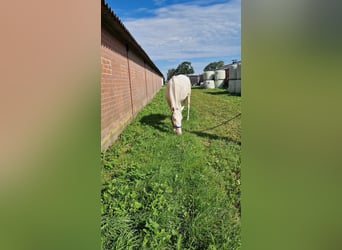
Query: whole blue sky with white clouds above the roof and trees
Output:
[[106, 0, 241, 77]]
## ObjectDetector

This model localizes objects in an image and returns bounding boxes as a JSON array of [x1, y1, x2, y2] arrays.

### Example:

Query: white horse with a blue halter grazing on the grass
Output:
[[165, 75, 191, 135]]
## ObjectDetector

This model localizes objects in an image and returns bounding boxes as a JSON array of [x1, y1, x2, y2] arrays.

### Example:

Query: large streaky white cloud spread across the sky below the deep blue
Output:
[[123, 0, 241, 73]]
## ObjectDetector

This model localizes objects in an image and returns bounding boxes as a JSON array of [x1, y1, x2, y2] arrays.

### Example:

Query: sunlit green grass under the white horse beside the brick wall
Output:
[[101, 88, 241, 249]]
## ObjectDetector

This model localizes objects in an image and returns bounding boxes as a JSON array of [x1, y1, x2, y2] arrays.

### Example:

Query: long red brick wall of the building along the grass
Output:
[[101, 28, 162, 150]]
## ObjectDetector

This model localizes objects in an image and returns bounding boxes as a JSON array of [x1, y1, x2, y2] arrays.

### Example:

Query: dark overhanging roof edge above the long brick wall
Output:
[[101, 0, 163, 77]]
